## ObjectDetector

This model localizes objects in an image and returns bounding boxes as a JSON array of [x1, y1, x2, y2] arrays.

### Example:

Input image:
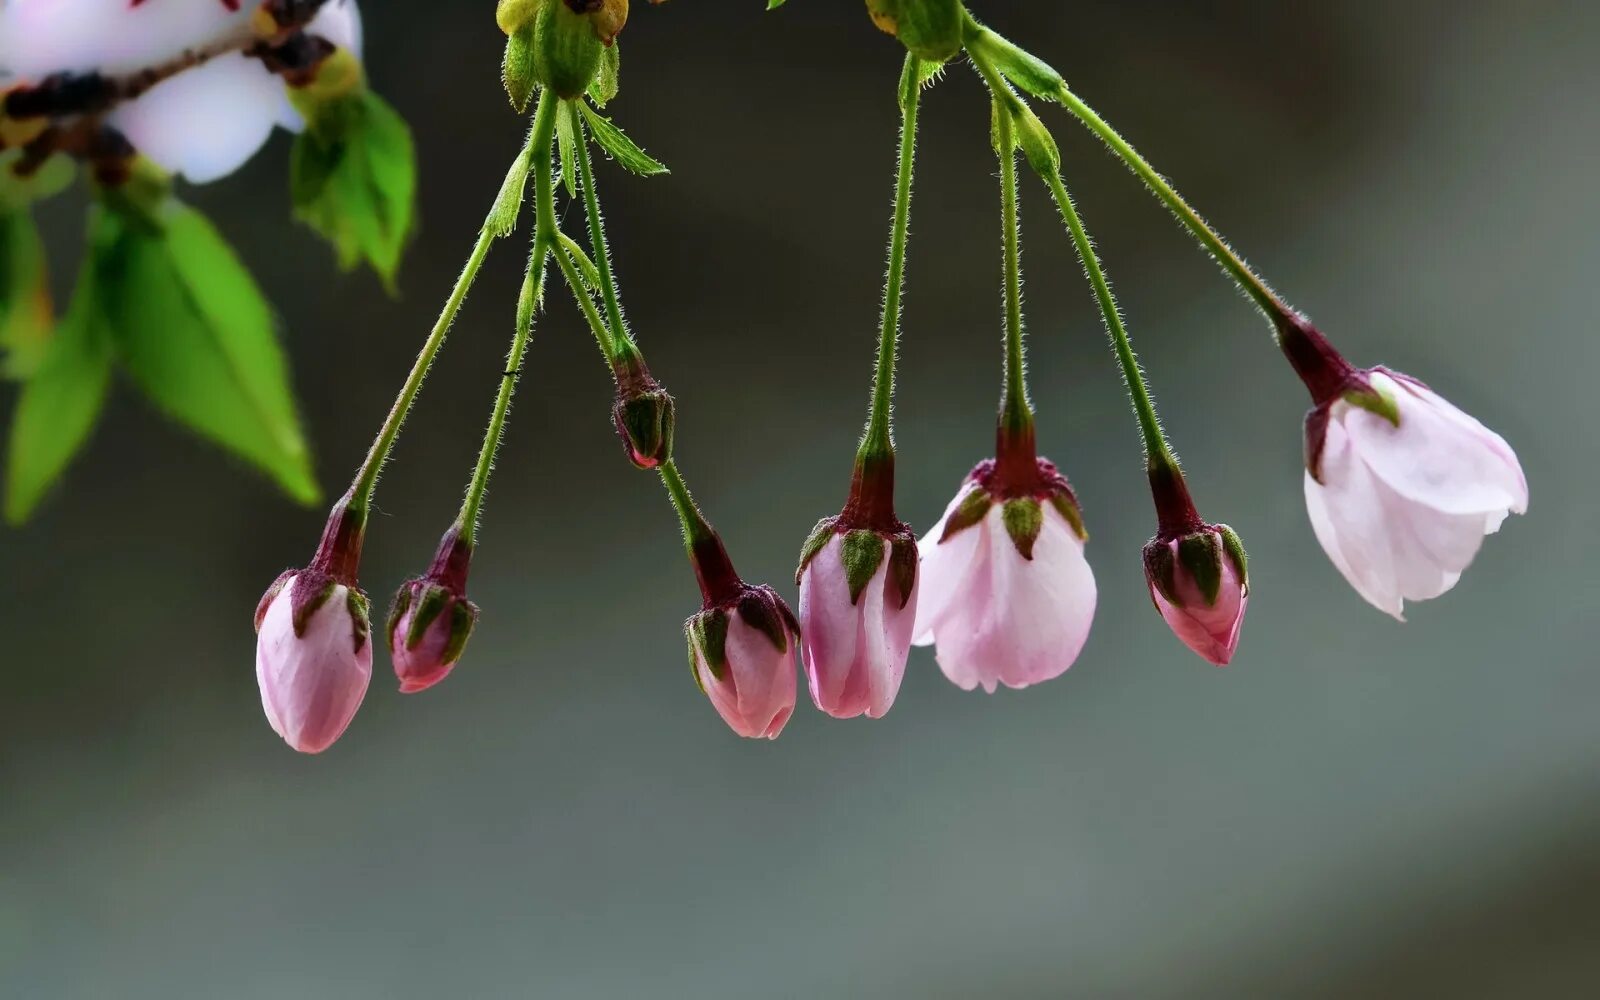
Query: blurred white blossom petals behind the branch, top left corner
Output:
[[0, 0, 362, 184]]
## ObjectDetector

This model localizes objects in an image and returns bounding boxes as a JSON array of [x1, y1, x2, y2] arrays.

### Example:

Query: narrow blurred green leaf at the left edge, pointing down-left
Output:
[[5, 248, 112, 525]]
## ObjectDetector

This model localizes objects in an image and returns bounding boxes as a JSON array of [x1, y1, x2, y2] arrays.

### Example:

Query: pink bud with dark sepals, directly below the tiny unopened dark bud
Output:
[[683, 584, 800, 739]]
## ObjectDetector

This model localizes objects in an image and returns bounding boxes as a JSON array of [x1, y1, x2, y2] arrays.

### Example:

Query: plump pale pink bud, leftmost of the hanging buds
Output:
[[256, 570, 373, 754]]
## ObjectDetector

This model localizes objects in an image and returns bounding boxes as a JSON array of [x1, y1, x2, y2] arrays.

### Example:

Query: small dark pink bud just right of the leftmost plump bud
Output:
[[387, 526, 478, 694]]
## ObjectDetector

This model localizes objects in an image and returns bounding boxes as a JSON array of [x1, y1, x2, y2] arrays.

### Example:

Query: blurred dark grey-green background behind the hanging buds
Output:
[[0, 0, 1600, 1000]]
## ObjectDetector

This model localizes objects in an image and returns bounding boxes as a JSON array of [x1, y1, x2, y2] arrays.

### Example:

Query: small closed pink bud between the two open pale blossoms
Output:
[[1144, 525, 1250, 667]]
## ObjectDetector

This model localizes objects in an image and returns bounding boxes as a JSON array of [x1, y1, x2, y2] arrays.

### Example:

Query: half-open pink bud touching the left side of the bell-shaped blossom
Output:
[[798, 518, 917, 718]]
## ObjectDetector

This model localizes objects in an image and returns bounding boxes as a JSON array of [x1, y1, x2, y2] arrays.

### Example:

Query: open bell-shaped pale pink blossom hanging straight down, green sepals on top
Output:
[[914, 459, 1098, 693]]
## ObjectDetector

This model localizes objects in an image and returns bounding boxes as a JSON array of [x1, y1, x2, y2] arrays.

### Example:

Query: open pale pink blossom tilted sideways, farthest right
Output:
[[1306, 368, 1528, 621]]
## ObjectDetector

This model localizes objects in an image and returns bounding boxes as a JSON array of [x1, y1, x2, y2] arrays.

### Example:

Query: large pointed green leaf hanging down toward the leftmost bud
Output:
[[93, 200, 318, 504]]
